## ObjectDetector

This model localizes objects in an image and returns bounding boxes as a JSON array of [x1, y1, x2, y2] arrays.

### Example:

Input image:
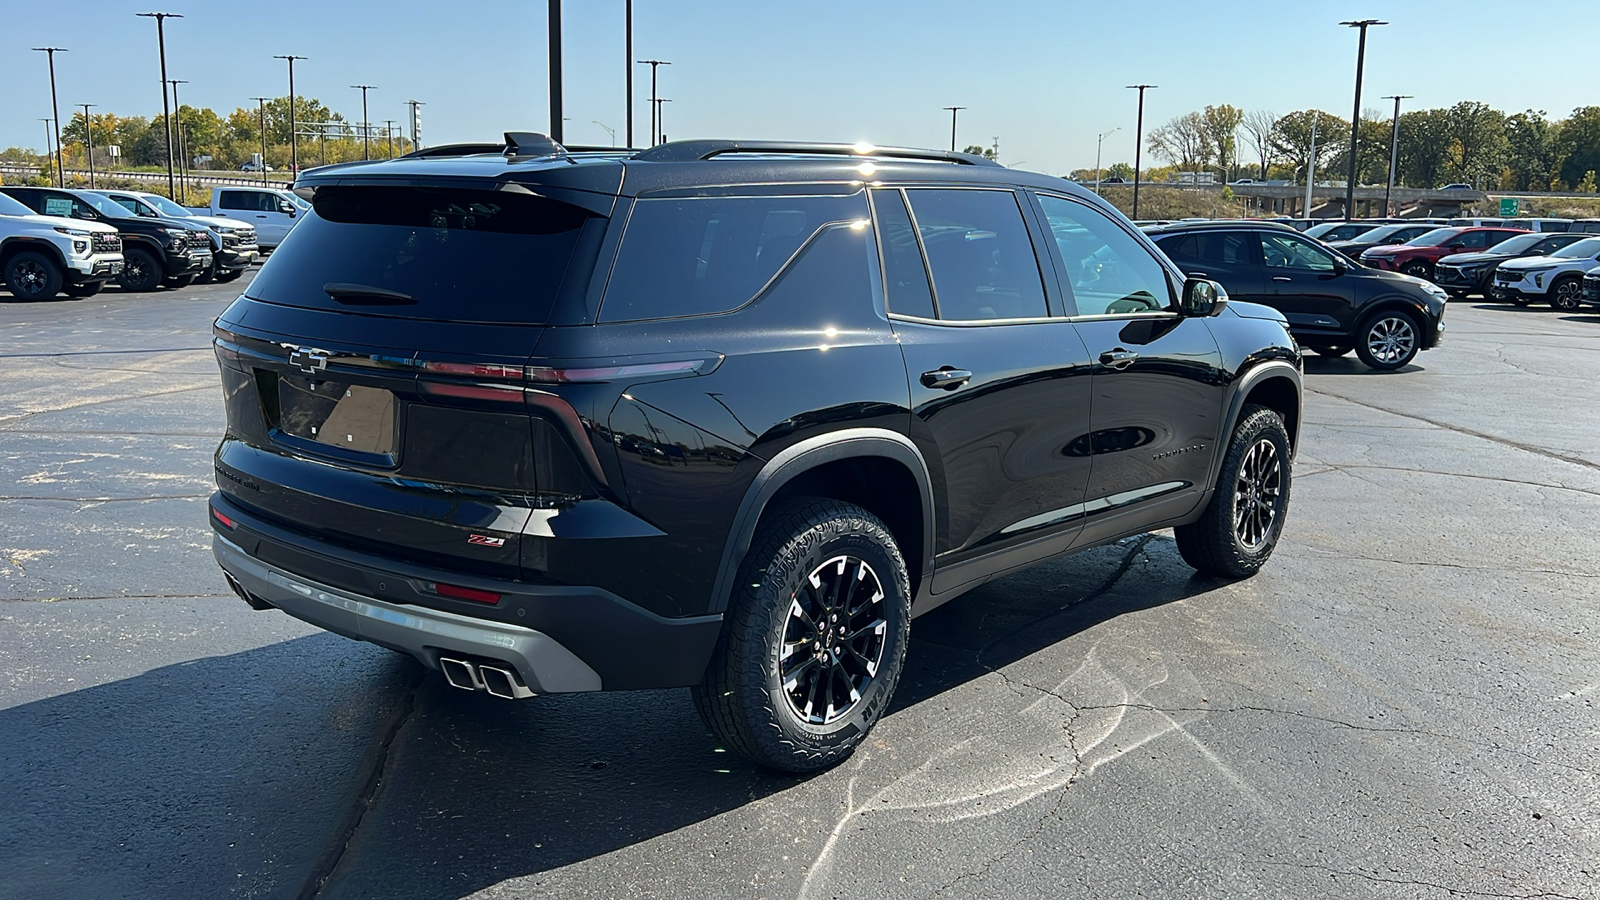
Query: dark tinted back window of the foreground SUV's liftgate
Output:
[[246, 186, 590, 325]]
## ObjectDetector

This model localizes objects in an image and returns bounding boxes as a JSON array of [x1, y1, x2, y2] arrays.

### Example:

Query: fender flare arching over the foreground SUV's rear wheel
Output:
[[707, 428, 936, 613]]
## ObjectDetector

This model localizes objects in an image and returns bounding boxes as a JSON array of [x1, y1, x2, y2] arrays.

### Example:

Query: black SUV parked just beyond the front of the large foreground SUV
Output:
[[1146, 223, 1448, 370]]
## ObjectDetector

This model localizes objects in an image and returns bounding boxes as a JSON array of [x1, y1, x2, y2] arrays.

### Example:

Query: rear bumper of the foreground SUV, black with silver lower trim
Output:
[[211, 493, 722, 693]]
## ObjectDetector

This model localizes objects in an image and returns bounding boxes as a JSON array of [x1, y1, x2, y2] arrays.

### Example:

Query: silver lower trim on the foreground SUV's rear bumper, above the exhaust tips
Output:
[[211, 535, 602, 693]]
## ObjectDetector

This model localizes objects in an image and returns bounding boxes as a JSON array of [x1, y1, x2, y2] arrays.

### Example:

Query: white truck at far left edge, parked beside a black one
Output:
[[0, 194, 123, 299]]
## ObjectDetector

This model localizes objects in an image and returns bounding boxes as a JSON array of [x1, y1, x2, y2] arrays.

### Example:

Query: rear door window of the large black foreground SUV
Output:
[[906, 189, 1050, 322]]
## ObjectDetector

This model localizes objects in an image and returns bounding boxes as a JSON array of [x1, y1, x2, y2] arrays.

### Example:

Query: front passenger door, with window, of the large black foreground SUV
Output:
[[1038, 194, 1227, 544]]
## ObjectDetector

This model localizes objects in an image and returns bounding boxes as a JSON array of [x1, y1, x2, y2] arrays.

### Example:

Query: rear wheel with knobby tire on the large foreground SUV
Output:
[[693, 498, 910, 772]]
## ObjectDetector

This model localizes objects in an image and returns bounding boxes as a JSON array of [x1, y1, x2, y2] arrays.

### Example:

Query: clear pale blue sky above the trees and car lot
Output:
[[0, 0, 1600, 173]]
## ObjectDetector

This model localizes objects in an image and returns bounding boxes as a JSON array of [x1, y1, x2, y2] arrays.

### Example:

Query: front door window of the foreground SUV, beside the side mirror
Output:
[[1038, 194, 1173, 315]]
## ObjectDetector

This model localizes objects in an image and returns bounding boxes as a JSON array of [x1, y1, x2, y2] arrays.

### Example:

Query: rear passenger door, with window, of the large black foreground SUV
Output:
[[872, 187, 1091, 594]]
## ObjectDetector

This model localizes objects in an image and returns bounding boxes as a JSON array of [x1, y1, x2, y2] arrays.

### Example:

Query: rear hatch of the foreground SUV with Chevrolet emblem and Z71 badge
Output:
[[216, 184, 611, 577]]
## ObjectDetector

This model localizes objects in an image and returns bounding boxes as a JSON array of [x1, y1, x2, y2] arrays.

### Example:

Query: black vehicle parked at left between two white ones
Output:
[[0, 184, 211, 291]]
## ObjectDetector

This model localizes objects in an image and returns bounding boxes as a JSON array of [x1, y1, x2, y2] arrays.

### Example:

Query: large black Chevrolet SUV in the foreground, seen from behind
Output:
[[211, 133, 1301, 772]]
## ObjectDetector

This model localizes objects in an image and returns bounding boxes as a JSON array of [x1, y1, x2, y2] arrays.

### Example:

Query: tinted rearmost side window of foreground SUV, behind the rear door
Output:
[[600, 194, 867, 322]]
